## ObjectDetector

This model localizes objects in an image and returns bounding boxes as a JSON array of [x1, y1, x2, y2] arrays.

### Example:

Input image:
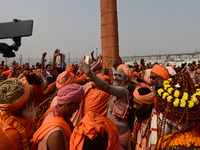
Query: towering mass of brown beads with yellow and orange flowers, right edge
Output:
[[156, 72, 200, 150]]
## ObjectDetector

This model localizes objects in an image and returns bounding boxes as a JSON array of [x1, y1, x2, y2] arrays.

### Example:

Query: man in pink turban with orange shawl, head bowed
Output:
[[33, 84, 84, 150]]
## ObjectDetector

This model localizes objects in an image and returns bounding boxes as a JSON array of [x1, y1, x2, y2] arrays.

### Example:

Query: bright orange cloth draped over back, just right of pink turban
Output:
[[82, 88, 110, 116]]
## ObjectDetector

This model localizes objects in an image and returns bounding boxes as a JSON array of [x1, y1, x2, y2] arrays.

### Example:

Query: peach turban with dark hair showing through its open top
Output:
[[133, 86, 155, 105]]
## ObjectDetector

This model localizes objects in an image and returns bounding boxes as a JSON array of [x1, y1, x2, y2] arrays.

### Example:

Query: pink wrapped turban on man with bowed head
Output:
[[57, 83, 84, 105]]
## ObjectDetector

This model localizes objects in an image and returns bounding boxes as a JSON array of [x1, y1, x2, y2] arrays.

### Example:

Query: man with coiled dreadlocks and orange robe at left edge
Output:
[[0, 78, 36, 150]]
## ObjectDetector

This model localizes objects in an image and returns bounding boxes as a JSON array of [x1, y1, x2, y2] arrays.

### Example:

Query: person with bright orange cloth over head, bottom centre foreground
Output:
[[70, 111, 119, 150]]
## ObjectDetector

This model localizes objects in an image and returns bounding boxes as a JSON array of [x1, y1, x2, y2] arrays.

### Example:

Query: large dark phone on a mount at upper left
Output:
[[0, 20, 33, 39]]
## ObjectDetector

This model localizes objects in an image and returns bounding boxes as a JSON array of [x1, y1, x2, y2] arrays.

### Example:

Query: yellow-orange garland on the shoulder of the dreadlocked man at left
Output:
[[1, 111, 30, 150]]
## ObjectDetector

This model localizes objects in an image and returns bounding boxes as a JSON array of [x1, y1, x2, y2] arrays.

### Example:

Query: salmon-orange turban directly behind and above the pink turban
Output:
[[56, 71, 75, 90]]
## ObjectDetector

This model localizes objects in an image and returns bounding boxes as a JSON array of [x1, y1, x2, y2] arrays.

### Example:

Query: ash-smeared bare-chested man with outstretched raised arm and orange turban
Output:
[[79, 59, 131, 149]]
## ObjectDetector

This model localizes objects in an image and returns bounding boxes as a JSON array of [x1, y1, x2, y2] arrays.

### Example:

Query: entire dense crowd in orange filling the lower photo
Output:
[[0, 49, 200, 150]]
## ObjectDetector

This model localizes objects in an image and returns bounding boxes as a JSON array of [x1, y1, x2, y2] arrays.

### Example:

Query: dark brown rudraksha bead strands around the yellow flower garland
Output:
[[156, 72, 200, 150]]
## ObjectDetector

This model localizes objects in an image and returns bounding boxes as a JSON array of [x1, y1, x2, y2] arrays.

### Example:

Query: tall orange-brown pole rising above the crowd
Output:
[[101, 0, 119, 77]]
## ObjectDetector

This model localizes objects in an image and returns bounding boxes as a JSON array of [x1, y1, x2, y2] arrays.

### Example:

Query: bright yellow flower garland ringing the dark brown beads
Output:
[[157, 78, 200, 108]]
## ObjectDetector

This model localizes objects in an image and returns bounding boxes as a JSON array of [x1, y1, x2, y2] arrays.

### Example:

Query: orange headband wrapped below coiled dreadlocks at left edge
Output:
[[0, 82, 30, 112]]
